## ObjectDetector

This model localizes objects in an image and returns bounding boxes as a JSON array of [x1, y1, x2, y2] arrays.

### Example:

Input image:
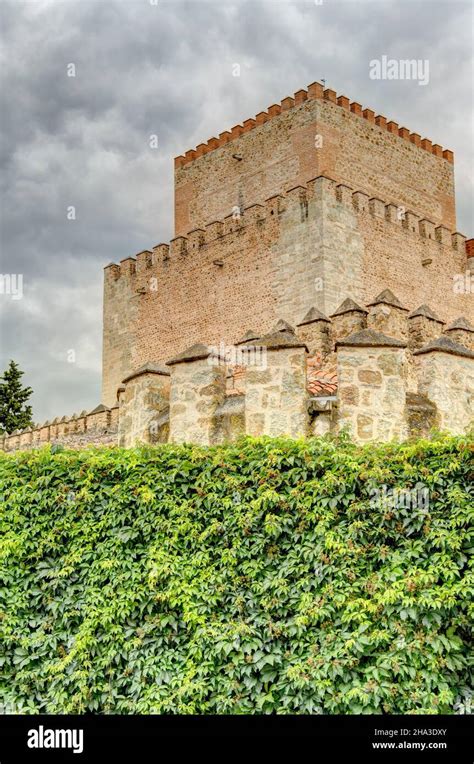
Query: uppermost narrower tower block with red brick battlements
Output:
[[175, 82, 456, 236]]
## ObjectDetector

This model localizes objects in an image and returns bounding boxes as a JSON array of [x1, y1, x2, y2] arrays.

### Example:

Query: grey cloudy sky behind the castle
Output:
[[0, 0, 474, 422]]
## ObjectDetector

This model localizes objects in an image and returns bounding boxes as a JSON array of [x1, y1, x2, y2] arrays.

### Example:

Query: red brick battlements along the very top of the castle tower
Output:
[[174, 82, 454, 168]]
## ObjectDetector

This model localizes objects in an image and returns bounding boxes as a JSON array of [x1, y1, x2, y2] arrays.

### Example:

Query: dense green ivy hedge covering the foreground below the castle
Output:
[[0, 436, 474, 714]]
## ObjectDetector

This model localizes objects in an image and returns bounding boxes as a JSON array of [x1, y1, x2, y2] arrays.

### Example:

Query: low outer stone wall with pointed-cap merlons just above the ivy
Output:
[[4, 289, 474, 450]]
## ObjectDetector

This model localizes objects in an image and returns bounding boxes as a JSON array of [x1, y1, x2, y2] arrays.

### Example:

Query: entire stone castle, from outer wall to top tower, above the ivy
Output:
[[8, 83, 474, 449]]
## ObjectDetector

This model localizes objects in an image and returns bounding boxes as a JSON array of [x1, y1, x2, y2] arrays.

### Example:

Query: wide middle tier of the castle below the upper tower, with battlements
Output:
[[103, 176, 472, 406]]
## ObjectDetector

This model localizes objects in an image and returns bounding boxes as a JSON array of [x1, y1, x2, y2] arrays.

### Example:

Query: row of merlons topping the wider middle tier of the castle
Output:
[[105, 175, 474, 280]]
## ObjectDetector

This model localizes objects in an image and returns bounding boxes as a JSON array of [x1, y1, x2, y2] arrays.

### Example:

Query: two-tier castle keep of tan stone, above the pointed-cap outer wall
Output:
[[102, 83, 474, 406]]
